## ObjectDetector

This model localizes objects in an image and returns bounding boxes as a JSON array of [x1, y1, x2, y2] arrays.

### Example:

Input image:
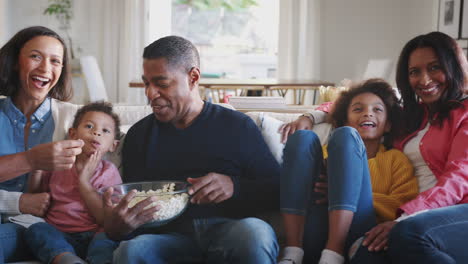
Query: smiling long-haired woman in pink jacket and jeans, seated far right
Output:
[[363, 32, 468, 264]]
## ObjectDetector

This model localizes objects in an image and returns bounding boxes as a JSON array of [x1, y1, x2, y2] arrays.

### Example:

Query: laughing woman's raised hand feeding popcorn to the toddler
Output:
[[26, 140, 84, 171]]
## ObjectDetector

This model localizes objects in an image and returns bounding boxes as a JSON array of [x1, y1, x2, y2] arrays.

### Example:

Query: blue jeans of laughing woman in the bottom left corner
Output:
[[0, 223, 33, 263]]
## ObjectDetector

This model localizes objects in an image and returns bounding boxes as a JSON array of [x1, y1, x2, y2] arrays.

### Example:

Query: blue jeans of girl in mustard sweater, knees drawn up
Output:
[[280, 127, 377, 263]]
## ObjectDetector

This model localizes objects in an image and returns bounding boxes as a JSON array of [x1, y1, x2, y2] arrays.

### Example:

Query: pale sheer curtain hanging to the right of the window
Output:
[[278, 0, 322, 104]]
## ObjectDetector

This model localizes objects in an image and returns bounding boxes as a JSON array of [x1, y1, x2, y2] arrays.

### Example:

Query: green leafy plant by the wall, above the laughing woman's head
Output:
[[43, 0, 75, 59]]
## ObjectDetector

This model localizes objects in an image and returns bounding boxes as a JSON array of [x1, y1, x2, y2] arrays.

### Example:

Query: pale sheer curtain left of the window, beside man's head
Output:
[[90, 0, 148, 104]]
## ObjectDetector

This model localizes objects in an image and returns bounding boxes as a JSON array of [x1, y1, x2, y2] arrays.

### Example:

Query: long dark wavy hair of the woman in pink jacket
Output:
[[396, 32, 468, 134]]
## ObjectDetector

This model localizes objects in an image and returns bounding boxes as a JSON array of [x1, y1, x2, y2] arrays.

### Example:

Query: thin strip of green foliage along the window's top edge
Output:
[[175, 0, 257, 11]]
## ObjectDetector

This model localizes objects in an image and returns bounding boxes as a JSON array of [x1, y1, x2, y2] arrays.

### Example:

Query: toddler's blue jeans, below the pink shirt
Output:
[[24, 223, 95, 263]]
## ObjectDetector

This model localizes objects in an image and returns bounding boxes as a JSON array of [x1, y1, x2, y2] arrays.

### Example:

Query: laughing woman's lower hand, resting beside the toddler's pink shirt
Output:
[[19, 192, 50, 217]]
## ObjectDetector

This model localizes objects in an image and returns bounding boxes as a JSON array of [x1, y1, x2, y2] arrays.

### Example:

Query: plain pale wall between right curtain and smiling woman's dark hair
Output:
[[320, 0, 439, 83]]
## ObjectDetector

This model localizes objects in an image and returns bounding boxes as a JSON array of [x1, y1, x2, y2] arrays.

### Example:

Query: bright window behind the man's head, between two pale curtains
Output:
[[169, 0, 279, 79]]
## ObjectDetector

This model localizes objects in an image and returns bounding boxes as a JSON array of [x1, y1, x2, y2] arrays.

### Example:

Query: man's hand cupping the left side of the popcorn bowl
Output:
[[102, 188, 159, 240]]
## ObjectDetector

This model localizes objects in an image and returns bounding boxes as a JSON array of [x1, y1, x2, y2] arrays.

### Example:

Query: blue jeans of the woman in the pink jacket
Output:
[[388, 204, 468, 264]]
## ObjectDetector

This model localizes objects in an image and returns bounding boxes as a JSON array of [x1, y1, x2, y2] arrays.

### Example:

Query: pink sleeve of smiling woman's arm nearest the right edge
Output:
[[401, 116, 468, 214]]
